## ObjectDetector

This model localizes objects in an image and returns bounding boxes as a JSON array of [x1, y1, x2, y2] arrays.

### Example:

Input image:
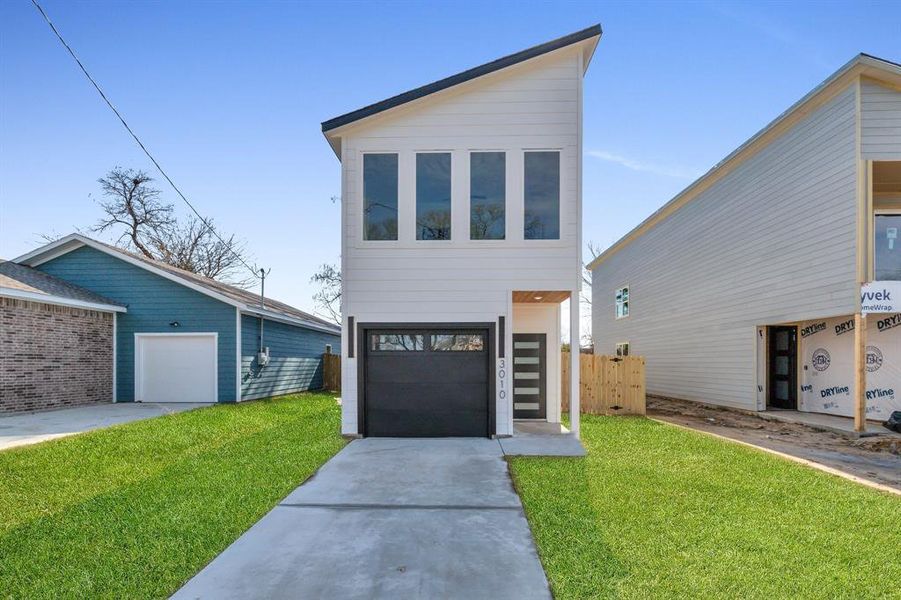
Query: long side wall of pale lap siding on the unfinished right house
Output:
[[592, 85, 858, 410]]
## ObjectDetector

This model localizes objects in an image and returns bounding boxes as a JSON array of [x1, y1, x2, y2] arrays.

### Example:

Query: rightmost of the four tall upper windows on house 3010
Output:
[[523, 152, 560, 240]]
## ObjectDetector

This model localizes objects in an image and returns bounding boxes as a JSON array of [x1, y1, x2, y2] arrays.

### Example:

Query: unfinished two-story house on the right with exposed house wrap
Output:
[[589, 55, 901, 430]]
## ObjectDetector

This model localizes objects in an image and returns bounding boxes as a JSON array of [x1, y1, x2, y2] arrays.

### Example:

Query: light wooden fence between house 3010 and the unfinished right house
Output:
[[560, 352, 645, 415]]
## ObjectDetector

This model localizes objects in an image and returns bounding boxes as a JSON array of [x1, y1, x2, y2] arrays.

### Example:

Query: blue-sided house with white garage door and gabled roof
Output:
[[15, 234, 341, 402]]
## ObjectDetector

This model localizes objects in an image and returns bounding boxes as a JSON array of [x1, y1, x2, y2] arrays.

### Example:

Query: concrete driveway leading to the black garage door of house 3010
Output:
[[173, 438, 550, 599]]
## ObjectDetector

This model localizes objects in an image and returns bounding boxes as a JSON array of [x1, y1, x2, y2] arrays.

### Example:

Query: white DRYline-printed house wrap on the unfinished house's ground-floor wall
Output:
[[799, 314, 901, 419]]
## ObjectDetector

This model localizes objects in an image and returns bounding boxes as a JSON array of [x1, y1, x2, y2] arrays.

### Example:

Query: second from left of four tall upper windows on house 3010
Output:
[[416, 152, 450, 240]]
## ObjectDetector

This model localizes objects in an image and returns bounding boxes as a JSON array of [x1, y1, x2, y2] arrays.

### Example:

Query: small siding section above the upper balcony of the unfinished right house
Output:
[[860, 80, 901, 160]]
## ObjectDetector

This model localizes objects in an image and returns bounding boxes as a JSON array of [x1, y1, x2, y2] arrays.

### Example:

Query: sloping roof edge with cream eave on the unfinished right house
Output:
[[587, 53, 901, 270]]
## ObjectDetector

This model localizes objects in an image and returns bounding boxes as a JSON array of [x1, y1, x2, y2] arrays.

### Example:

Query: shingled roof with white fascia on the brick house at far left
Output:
[[0, 259, 126, 312]]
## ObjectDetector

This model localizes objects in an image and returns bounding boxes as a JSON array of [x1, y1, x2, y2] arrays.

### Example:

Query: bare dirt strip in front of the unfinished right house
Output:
[[647, 396, 901, 490]]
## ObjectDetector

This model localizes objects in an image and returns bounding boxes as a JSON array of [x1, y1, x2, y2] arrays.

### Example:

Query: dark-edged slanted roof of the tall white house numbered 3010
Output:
[[322, 24, 602, 158]]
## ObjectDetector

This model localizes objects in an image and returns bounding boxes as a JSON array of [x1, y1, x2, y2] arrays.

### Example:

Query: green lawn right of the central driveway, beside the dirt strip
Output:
[[510, 416, 901, 600]]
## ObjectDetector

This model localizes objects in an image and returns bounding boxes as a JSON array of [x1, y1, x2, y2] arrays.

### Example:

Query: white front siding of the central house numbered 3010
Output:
[[341, 48, 582, 433]]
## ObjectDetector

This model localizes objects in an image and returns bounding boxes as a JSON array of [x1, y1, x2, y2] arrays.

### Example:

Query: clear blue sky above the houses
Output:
[[0, 0, 901, 318]]
